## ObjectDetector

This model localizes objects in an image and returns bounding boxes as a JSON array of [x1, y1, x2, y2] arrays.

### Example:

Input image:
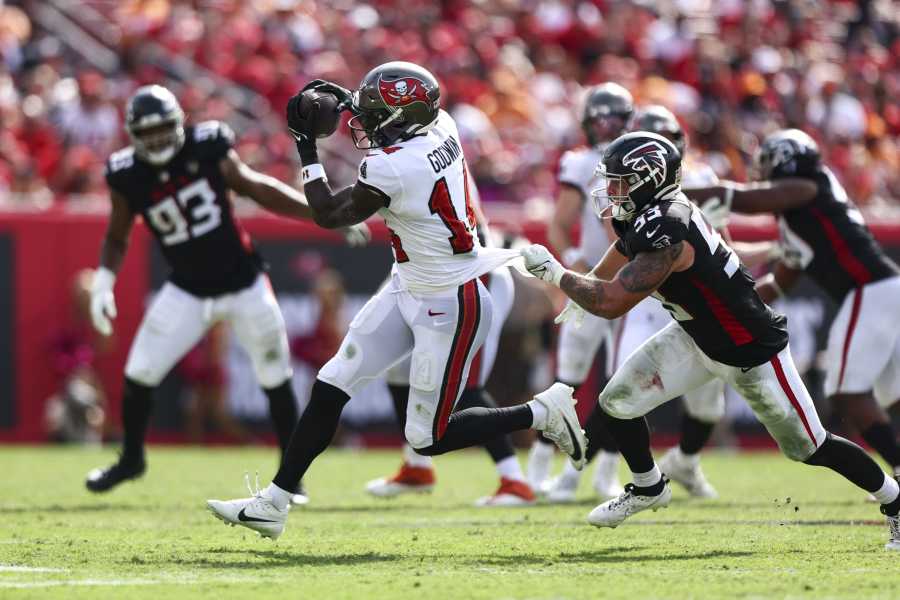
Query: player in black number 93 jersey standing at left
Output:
[[86, 85, 366, 502]]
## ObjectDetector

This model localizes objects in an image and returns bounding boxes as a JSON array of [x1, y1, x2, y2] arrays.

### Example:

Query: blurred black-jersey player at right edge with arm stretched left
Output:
[[689, 129, 900, 482]]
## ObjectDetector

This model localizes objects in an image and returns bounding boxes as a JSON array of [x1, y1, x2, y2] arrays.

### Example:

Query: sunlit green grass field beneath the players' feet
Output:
[[0, 447, 900, 600]]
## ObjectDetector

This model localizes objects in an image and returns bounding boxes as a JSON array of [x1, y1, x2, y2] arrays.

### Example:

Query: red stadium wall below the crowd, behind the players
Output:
[[0, 211, 900, 442]]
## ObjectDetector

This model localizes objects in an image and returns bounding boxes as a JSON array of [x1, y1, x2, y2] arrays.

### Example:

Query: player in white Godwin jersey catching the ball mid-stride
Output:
[[207, 62, 587, 538]]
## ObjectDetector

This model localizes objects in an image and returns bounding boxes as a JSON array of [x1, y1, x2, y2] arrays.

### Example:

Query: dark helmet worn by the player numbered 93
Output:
[[125, 85, 184, 165]]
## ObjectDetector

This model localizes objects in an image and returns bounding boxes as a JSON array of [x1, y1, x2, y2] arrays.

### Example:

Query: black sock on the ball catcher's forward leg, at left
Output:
[[272, 379, 350, 491]]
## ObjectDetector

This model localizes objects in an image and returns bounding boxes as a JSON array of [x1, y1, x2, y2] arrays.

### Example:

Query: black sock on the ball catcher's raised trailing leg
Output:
[[416, 404, 534, 456]]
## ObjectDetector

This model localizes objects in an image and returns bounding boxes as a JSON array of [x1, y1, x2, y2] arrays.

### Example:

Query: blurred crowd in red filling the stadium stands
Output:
[[0, 0, 900, 208]]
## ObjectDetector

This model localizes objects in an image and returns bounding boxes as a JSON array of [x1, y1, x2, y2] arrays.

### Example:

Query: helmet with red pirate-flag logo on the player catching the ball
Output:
[[349, 61, 441, 149]]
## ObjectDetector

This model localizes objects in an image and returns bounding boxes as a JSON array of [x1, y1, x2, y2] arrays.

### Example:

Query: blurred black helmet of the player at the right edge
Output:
[[753, 129, 822, 181]]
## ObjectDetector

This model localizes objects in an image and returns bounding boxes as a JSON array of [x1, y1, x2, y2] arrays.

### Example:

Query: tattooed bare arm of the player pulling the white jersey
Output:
[[559, 242, 694, 319]]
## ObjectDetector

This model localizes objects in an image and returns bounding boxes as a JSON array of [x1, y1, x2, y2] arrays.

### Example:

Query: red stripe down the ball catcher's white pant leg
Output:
[[432, 280, 481, 441]]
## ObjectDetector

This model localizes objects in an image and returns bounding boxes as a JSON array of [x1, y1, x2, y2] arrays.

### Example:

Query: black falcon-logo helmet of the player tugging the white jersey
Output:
[[591, 131, 681, 221]]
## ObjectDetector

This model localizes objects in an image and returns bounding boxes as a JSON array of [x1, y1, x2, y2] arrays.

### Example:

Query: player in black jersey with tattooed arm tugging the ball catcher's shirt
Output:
[[522, 132, 900, 549]]
